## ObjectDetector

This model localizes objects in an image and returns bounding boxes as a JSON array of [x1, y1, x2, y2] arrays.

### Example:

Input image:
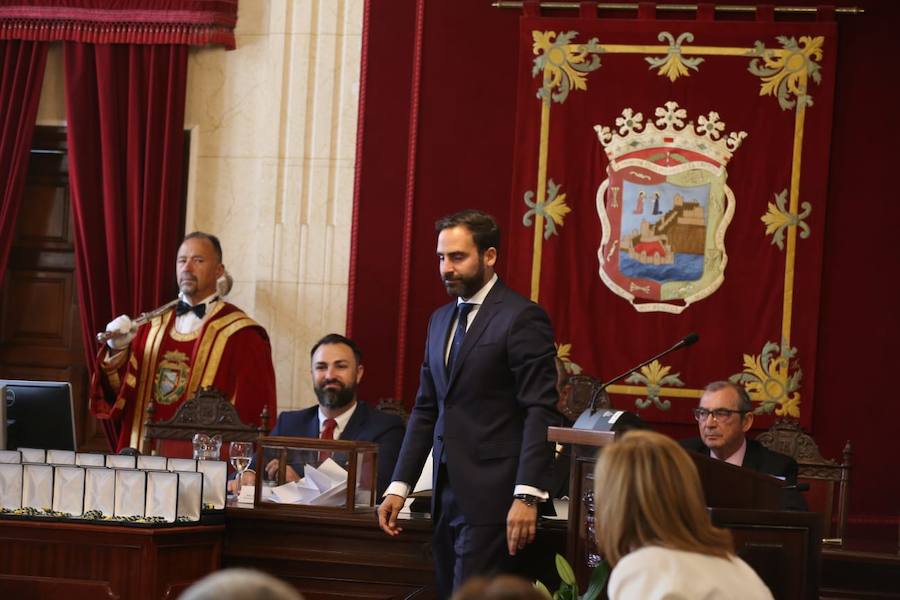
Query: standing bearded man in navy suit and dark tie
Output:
[[378, 210, 559, 598]]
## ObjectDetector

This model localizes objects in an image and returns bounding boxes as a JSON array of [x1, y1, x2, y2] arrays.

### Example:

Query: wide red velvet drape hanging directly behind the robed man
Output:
[[65, 42, 188, 440]]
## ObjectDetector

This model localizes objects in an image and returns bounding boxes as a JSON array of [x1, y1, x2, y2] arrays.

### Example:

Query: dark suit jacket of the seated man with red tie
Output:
[[269, 402, 404, 498]]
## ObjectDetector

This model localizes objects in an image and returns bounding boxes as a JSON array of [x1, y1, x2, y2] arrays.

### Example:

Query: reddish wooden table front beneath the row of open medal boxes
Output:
[[0, 520, 225, 600]]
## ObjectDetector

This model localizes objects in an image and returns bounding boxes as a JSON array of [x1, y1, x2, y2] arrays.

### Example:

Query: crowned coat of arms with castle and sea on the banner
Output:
[[594, 102, 747, 314]]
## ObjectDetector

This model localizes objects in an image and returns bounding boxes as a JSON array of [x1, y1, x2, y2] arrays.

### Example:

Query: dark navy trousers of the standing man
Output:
[[432, 463, 512, 599]]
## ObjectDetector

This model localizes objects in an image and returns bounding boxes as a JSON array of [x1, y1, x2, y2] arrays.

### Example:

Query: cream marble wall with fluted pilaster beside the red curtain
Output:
[[38, 0, 363, 410]]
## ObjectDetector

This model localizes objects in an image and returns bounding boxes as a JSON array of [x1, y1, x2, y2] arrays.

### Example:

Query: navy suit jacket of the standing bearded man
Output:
[[394, 281, 561, 525]]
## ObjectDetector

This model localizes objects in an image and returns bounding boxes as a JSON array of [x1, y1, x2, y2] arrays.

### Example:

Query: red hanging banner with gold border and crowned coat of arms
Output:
[[504, 13, 836, 427]]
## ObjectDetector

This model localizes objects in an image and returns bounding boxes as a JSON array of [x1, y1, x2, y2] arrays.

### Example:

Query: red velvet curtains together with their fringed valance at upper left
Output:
[[0, 0, 238, 450]]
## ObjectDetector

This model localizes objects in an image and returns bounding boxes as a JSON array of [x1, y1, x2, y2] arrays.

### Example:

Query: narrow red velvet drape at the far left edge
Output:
[[0, 40, 47, 282]]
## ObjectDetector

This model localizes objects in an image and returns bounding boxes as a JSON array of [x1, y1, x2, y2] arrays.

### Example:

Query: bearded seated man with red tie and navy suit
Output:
[[241, 333, 405, 497]]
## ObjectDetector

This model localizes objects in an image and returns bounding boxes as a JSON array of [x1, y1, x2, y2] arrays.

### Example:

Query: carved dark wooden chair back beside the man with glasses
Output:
[[756, 420, 853, 540]]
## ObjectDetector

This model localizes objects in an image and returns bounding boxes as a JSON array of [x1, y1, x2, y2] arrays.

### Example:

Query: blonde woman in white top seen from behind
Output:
[[594, 431, 772, 600]]
